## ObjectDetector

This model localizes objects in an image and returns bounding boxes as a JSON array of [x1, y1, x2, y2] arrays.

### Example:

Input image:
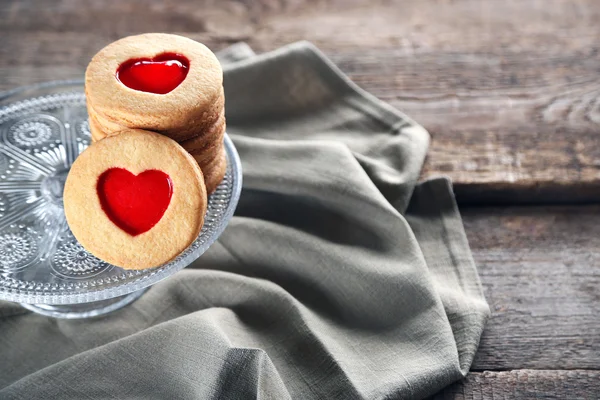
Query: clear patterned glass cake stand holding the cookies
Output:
[[0, 81, 242, 318]]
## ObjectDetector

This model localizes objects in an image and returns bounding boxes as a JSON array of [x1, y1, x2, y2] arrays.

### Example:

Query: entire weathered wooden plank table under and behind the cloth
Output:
[[0, 0, 600, 399]]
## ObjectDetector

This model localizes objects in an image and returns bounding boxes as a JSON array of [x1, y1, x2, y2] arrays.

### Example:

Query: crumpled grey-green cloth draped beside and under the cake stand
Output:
[[0, 43, 489, 400]]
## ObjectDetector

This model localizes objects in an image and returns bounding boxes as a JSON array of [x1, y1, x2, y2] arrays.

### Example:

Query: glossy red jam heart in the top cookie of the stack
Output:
[[116, 53, 190, 94]]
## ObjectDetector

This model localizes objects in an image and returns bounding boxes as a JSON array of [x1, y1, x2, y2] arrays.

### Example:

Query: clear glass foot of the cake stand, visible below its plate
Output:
[[21, 288, 148, 319]]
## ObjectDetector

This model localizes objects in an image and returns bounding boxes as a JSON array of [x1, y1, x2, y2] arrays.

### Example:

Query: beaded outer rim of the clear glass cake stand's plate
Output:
[[0, 80, 242, 305]]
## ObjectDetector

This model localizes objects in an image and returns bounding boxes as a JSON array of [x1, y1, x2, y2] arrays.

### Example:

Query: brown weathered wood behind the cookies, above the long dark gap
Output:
[[0, 0, 600, 203]]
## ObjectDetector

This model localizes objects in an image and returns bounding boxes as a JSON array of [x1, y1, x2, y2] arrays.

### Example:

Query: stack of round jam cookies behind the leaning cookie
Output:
[[85, 33, 227, 193]]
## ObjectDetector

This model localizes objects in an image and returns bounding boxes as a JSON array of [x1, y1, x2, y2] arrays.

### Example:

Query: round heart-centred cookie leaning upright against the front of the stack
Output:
[[63, 129, 207, 269]]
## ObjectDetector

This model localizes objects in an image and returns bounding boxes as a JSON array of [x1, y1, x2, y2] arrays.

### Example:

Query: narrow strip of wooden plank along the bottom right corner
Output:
[[431, 370, 600, 400]]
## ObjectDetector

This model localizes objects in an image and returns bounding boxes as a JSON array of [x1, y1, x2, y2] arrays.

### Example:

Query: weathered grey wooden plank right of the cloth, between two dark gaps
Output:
[[461, 206, 600, 370]]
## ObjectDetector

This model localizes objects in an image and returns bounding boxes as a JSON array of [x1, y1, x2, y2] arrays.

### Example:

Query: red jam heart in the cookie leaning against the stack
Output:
[[96, 168, 173, 236]]
